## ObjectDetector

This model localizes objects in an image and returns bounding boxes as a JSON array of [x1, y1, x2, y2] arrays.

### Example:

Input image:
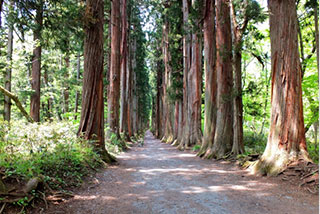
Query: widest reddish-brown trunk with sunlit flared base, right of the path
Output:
[[253, 0, 309, 175]]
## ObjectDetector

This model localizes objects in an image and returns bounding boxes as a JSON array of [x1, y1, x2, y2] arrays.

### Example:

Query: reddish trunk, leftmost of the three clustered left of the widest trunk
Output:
[[198, 0, 217, 157]]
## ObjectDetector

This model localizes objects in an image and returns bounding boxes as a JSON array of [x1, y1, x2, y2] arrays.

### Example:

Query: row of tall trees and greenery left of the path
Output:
[[0, 0, 151, 162]]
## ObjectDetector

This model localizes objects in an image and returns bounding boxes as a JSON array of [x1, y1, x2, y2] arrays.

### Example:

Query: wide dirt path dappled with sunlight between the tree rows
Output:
[[45, 132, 319, 214]]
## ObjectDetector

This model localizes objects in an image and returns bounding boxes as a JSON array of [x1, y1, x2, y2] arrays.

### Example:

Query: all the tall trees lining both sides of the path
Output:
[[0, 0, 319, 183]]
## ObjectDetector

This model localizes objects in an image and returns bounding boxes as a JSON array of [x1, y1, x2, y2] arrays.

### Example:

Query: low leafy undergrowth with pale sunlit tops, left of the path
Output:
[[0, 121, 102, 189]]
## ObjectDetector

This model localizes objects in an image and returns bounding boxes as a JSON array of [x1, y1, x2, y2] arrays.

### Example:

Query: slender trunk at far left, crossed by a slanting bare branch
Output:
[[4, 1, 13, 121]]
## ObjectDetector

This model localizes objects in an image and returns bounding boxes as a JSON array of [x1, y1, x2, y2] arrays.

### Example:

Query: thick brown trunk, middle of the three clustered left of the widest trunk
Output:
[[208, 0, 233, 158]]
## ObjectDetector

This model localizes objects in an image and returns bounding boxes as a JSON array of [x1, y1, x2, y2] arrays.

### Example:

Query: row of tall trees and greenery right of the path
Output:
[[150, 0, 319, 175]]
